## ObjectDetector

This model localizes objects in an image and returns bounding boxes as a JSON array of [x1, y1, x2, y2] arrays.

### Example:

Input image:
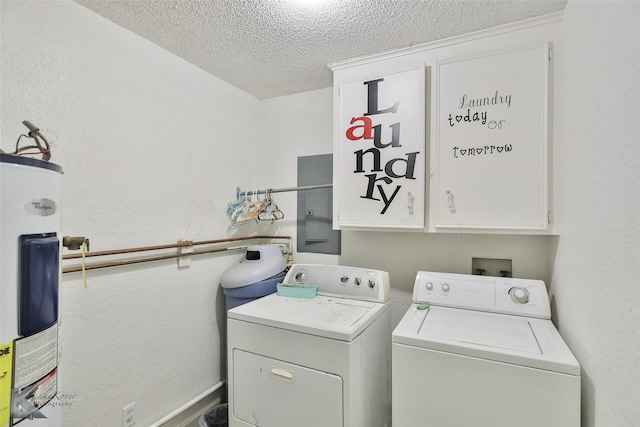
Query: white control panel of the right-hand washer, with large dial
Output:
[[413, 271, 551, 319]]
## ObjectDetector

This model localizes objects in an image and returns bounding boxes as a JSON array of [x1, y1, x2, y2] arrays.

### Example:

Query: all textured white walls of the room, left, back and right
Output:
[[0, 2, 640, 427]]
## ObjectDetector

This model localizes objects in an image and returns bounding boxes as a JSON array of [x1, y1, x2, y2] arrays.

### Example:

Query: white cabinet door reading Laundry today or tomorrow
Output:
[[431, 43, 549, 232]]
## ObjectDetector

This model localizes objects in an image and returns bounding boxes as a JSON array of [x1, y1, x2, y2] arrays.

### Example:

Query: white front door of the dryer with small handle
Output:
[[232, 349, 344, 427]]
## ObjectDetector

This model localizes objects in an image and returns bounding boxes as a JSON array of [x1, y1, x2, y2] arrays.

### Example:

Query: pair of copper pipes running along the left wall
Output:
[[62, 236, 291, 273]]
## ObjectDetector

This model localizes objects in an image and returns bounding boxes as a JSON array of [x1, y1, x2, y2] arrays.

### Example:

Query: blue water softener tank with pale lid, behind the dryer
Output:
[[220, 245, 287, 310]]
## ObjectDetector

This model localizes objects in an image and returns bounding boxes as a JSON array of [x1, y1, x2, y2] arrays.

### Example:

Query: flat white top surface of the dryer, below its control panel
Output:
[[228, 294, 386, 341]]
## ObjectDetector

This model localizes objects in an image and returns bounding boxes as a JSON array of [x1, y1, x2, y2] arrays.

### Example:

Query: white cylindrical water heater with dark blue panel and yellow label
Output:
[[0, 153, 64, 427]]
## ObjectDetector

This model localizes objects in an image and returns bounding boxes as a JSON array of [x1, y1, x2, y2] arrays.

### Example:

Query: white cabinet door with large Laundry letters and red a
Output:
[[334, 64, 425, 228]]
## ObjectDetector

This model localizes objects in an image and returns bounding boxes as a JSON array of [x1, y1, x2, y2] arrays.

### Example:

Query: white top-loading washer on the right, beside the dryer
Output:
[[392, 271, 580, 427]]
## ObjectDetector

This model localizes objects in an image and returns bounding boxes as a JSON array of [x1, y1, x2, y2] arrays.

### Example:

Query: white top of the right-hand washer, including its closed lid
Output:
[[392, 304, 580, 375]]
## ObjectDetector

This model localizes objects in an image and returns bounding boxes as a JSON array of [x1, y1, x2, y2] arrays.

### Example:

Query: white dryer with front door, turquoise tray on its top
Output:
[[227, 264, 391, 427]]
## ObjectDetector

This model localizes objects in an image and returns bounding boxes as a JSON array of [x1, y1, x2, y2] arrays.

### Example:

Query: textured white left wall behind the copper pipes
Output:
[[0, 1, 260, 427]]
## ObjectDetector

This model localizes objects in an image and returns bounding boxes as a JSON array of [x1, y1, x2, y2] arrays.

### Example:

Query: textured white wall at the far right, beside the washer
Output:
[[550, 1, 640, 427]]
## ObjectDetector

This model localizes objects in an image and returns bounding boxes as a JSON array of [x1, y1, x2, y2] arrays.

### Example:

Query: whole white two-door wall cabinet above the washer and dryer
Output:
[[331, 14, 560, 234]]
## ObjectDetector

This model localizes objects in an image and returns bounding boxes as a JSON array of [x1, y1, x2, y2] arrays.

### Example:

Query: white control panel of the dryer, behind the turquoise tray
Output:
[[283, 264, 391, 302]]
